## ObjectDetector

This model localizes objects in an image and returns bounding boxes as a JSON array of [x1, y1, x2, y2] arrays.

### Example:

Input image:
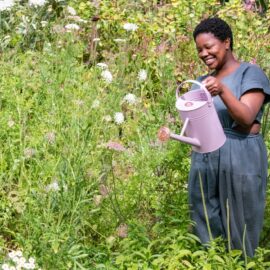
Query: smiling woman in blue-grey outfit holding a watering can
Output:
[[189, 18, 270, 256]]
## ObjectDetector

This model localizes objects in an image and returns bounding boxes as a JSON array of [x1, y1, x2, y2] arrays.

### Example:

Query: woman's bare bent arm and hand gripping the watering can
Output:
[[202, 76, 265, 128]]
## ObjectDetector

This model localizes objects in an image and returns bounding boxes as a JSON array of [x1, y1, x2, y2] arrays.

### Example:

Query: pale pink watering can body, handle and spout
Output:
[[170, 80, 226, 153]]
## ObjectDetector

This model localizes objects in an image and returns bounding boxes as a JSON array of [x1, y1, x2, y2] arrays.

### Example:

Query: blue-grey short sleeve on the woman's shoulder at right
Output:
[[241, 64, 270, 103]]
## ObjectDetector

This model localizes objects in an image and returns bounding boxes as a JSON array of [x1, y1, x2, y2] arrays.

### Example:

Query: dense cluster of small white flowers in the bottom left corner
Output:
[[2, 250, 36, 270]]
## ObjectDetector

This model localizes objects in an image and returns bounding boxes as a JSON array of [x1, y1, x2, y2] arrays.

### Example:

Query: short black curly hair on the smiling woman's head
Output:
[[193, 17, 233, 50]]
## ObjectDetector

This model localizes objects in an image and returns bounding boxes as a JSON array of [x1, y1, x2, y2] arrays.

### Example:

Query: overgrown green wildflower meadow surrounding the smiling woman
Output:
[[0, 0, 270, 270]]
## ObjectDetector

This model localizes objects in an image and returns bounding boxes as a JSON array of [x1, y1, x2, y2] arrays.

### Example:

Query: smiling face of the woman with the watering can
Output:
[[195, 33, 230, 70]]
